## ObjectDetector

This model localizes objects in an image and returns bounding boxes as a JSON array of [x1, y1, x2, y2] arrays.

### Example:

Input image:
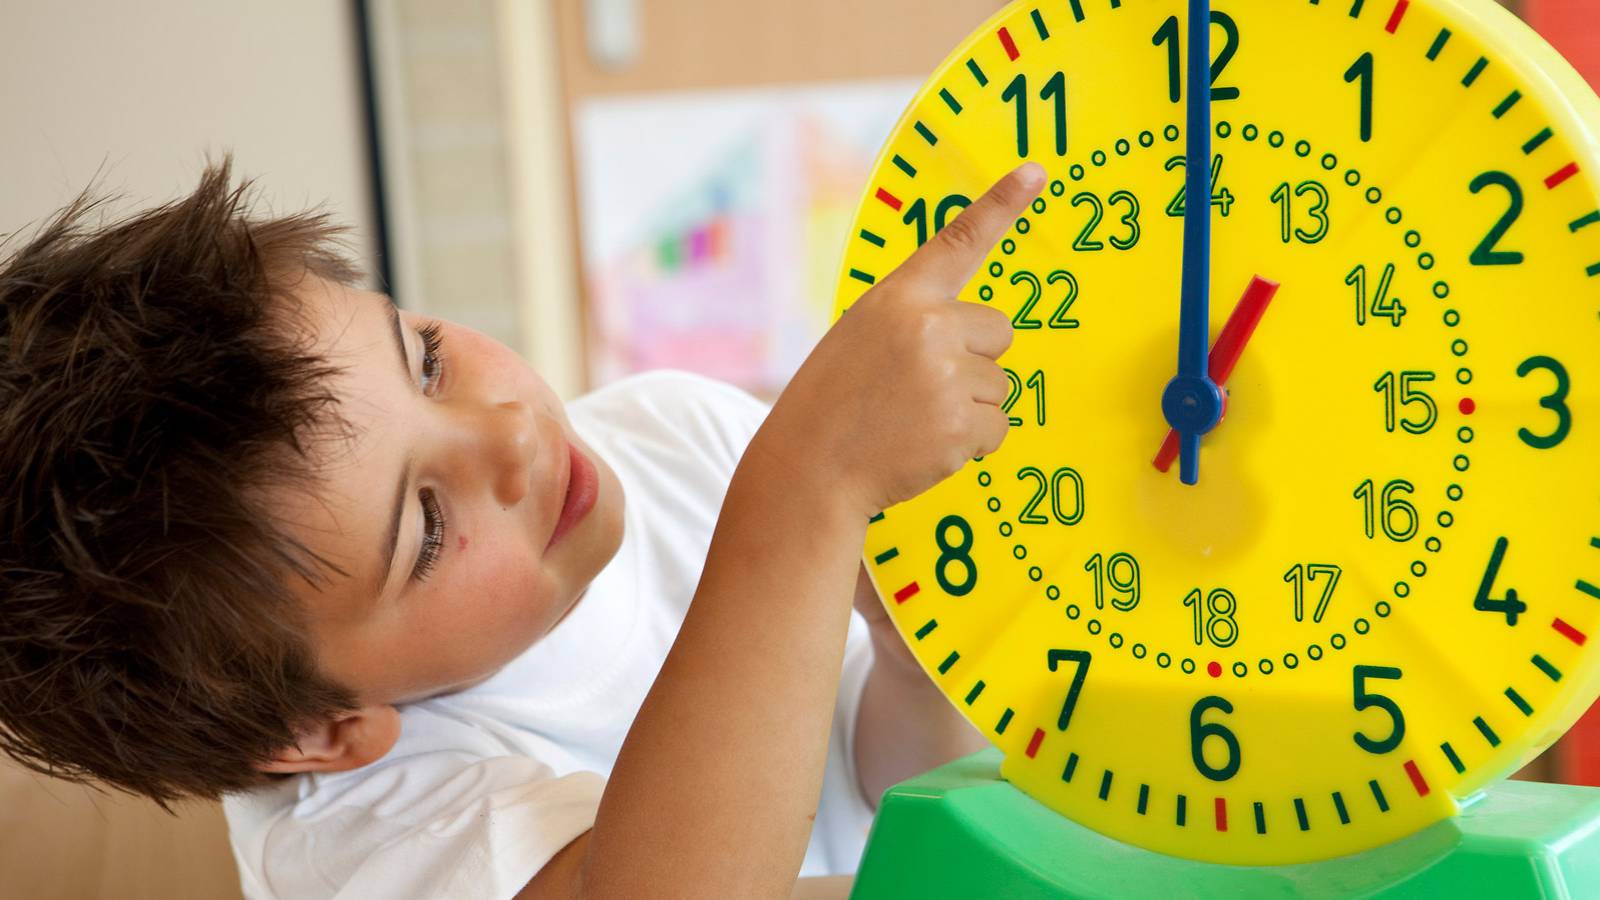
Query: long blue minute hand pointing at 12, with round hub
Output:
[[1162, 0, 1222, 484]]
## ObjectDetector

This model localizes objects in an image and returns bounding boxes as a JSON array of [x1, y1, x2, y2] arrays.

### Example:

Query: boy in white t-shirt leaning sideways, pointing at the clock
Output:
[[0, 157, 1045, 898]]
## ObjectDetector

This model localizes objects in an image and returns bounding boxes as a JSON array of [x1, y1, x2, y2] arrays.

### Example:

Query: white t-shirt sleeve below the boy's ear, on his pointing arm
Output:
[[226, 707, 605, 900]]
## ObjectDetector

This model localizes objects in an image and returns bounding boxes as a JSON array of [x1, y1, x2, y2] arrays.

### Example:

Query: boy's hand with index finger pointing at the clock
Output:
[[758, 163, 1045, 517]]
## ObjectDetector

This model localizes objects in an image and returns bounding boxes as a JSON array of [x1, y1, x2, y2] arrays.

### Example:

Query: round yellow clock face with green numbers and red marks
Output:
[[837, 0, 1600, 863]]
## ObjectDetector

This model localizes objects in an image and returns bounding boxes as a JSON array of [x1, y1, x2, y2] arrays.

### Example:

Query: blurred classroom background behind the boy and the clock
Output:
[[0, 0, 1600, 898]]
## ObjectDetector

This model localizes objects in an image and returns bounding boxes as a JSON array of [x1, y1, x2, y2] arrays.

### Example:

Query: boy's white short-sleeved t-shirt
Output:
[[224, 373, 872, 900]]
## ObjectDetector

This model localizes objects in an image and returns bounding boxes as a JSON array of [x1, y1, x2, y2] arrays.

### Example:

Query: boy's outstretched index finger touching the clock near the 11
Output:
[[901, 162, 1045, 296]]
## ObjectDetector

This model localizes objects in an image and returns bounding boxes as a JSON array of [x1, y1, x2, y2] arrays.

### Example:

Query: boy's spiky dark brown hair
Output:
[[0, 157, 358, 807]]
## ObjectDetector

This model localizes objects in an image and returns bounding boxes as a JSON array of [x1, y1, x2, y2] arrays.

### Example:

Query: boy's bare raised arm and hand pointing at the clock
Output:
[[525, 163, 1045, 898]]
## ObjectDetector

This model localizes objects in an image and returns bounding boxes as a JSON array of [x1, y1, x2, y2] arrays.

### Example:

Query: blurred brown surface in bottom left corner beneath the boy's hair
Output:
[[0, 757, 242, 900]]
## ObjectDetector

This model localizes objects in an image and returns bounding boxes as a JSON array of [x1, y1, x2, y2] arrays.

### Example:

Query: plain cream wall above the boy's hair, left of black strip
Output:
[[0, 0, 374, 277]]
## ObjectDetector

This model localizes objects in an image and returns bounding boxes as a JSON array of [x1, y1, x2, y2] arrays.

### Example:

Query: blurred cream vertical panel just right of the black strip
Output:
[[370, 0, 584, 397]]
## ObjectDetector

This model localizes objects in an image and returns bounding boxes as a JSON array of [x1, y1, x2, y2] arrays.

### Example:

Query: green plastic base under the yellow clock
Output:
[[851, 749, 1600, 900]]
